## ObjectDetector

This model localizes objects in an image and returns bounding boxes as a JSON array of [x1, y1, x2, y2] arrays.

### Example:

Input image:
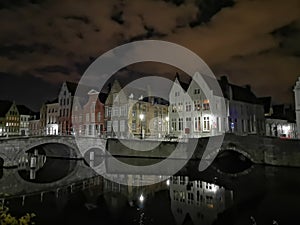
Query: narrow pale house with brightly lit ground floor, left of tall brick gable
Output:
[[46, 99, 59, 135]]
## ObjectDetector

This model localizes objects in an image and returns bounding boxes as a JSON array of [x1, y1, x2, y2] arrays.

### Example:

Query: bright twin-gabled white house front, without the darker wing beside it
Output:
[[169, 73, 228, 138]]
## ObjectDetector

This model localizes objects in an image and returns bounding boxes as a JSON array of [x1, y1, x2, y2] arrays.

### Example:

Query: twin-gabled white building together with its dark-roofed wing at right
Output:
[[169, 74, 265, 137]]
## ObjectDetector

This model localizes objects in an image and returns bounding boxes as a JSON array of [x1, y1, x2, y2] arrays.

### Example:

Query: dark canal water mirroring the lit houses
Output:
[[0, 155, 300, 225]]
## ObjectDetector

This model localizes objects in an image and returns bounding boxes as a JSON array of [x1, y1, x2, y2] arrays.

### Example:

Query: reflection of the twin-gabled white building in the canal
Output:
[[170, 176, 233, 224]]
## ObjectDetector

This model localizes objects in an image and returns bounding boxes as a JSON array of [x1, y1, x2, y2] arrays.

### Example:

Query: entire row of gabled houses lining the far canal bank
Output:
[[0, 74, 300, 139]]
